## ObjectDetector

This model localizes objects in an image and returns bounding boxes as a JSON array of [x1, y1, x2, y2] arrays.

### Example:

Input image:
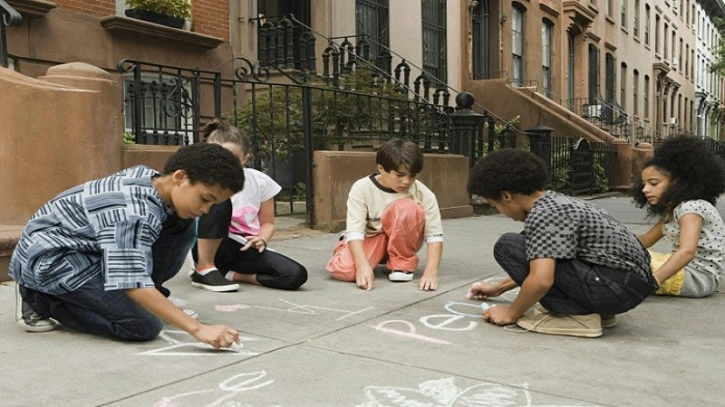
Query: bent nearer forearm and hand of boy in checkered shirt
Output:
[[483, 258, 556, 325]]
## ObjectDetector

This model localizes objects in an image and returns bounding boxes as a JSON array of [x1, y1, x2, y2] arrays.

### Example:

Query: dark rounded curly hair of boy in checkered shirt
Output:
[[468, 148, 548, 200]]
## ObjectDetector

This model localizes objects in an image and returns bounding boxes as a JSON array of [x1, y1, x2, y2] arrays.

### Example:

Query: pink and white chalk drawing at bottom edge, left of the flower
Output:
[[154, 371, 281, 407]]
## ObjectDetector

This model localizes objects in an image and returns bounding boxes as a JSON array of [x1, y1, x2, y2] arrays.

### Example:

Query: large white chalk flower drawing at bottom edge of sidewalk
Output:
[[356, 377, 596, 407]]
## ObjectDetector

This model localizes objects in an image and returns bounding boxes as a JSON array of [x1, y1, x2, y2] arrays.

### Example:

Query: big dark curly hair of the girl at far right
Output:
[[631, 135, 725, 216]]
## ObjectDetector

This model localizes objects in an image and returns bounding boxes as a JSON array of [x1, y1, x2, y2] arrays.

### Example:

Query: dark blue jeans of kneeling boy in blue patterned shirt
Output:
[[20, 215, 194, 341]]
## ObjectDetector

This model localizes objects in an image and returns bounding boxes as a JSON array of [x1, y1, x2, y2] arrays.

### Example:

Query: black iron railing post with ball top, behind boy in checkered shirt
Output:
[[449, 92, 485, 167]]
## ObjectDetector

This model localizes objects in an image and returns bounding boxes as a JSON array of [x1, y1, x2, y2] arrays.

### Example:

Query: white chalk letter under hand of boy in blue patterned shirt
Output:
[[138, 330, 258, 356]]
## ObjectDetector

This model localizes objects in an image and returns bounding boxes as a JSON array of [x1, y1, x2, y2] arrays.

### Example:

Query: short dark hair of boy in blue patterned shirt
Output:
[[163, 143, 244, 193]]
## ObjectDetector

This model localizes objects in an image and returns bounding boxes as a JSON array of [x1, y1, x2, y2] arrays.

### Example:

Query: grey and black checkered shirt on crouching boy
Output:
[[524, 191, 650, 280]]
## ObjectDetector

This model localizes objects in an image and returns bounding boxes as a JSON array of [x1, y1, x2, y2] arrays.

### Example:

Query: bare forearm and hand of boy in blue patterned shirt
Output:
[[126, 287, 240, 348]]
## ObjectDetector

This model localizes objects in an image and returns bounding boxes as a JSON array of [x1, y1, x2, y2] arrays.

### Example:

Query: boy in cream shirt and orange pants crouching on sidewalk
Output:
[[326, 139, 443, 291]]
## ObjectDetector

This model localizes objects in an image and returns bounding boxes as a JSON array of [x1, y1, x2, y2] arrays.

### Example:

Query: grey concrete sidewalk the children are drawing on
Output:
[[0, 198, 725, 407]]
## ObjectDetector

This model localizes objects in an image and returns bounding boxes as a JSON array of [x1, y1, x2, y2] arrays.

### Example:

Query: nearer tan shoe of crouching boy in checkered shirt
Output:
[[516, 313, 602, 338]]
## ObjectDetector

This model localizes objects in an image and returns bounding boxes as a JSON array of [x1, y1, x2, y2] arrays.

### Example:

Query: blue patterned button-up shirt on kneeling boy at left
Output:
[[9, 166, 172, 294]]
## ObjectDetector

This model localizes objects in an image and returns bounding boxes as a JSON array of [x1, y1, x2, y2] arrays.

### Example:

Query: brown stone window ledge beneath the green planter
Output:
[[101, 15, 224, 49]]
